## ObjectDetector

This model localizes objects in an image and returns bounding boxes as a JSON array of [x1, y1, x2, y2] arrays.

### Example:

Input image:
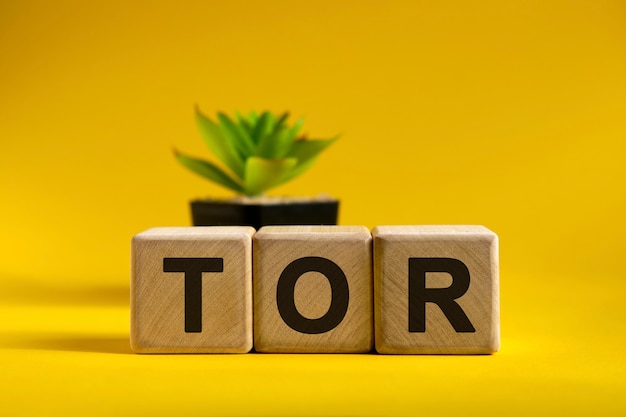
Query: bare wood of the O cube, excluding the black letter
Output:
[[253, 226, 373, 353]]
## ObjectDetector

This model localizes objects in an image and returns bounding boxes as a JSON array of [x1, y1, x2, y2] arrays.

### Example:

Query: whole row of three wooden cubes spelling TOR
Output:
[[131, 226, 500, 354]]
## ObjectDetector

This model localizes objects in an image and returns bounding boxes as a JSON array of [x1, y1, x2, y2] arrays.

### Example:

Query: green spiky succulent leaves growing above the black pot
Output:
[[174, 107, 338, 196]]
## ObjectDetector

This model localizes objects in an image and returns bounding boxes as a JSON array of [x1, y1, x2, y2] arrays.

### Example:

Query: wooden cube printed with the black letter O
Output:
[[254, 226, 374, 353]]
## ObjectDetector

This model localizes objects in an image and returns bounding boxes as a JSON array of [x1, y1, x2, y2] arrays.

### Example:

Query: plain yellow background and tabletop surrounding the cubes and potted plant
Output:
[[0, 0, 626, 416]]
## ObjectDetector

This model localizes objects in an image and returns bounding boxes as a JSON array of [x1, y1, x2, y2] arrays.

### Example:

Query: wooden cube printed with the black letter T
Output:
[[130, 227, 255, 353]]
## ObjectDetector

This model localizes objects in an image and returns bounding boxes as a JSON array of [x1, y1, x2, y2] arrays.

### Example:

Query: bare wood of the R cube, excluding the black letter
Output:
[[372, 226, 500, 354]]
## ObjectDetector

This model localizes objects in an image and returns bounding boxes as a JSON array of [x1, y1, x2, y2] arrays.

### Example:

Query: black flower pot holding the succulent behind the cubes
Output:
[[191, 197, 339, 229]]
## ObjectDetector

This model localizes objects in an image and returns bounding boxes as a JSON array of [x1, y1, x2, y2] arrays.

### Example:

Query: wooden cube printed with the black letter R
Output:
[[372, 226, 500, 354]]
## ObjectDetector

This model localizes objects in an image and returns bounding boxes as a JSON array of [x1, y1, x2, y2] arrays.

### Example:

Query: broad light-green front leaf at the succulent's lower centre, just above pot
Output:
[[244, 156, 298, 196]]
